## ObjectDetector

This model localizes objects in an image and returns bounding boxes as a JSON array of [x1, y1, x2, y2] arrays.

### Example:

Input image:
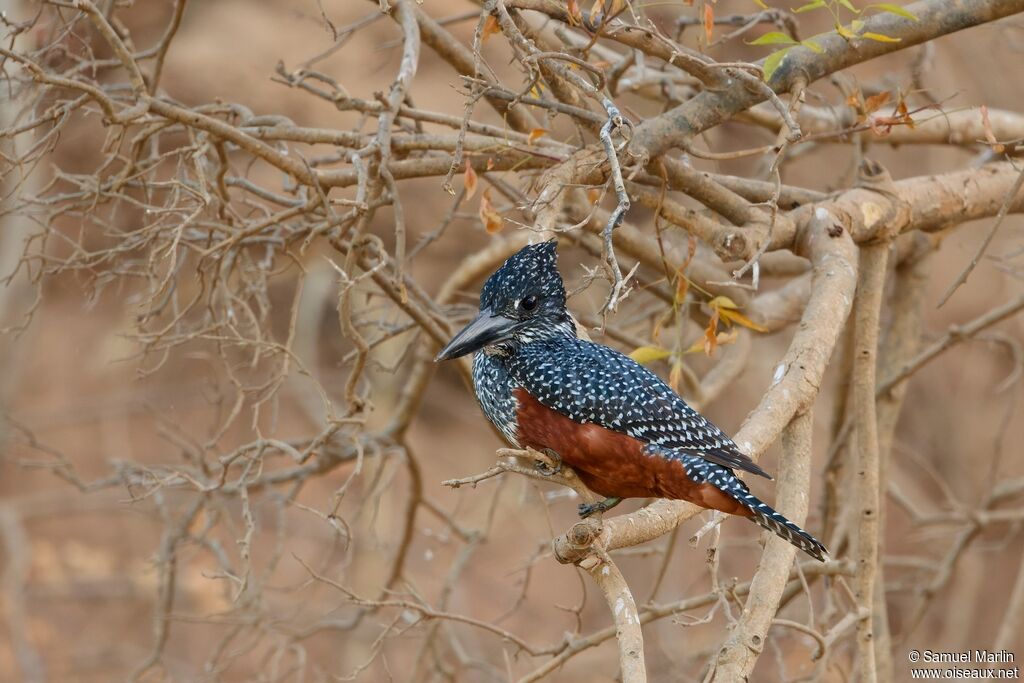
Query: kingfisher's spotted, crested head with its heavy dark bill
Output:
[[435, 240, 575, 360]]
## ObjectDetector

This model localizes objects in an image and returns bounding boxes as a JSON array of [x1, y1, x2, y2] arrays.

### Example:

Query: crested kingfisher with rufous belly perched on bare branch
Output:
[[435, 240, 827, 561]]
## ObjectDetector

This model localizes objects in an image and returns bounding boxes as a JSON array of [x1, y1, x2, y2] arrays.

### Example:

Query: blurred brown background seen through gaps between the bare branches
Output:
[[0, 0, 1024, 683]]
